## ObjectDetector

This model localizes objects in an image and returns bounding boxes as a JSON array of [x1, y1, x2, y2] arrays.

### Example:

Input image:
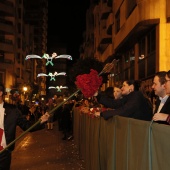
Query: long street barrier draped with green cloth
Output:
[[74, 108, 170, 170]]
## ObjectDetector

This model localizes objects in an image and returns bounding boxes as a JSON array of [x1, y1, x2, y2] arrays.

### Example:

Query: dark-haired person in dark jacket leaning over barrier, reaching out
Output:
[[96, 80, 153, 121]]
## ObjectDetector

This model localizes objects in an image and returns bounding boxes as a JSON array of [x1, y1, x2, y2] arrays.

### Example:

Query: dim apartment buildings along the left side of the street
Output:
[[0, 0, 48, 102]]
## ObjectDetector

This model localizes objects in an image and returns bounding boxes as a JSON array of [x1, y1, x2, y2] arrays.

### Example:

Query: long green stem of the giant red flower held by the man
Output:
[[0, 89, 80, 154]]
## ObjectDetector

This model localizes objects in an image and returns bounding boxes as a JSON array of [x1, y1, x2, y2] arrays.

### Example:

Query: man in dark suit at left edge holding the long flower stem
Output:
[[0, 83, 49, 170]]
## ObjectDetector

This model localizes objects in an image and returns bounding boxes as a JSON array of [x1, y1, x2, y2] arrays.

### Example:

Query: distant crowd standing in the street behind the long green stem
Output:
[[17, 95, 74, 140]]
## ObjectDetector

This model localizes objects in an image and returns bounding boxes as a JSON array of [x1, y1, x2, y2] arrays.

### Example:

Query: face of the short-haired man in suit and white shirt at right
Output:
[[152, 76, 166, 97]]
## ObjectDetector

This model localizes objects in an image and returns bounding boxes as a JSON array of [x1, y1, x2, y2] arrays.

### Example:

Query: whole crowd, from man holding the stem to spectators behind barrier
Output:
[[0, 70, 170, 170]]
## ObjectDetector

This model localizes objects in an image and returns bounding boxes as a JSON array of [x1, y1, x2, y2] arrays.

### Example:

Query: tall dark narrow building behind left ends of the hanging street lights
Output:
[[24, 0, 48, 101]]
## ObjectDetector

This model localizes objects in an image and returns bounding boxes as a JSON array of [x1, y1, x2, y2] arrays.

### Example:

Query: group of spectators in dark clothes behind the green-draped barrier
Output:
[[81, 71, 170, 124]]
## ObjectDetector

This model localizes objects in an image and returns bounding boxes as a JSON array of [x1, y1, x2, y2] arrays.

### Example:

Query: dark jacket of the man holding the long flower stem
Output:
[[3, 103, 43, 151]]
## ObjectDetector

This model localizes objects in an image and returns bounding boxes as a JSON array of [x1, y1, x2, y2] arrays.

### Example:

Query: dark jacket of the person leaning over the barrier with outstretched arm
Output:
[[100, 91, 153, 121]]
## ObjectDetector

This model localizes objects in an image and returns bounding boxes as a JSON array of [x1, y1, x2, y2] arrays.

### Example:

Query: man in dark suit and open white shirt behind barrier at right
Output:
[[152, 71, 170, 124]]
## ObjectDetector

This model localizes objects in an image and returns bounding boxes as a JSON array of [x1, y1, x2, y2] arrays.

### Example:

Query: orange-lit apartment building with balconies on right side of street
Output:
[[82, 0, 170, 89]]
